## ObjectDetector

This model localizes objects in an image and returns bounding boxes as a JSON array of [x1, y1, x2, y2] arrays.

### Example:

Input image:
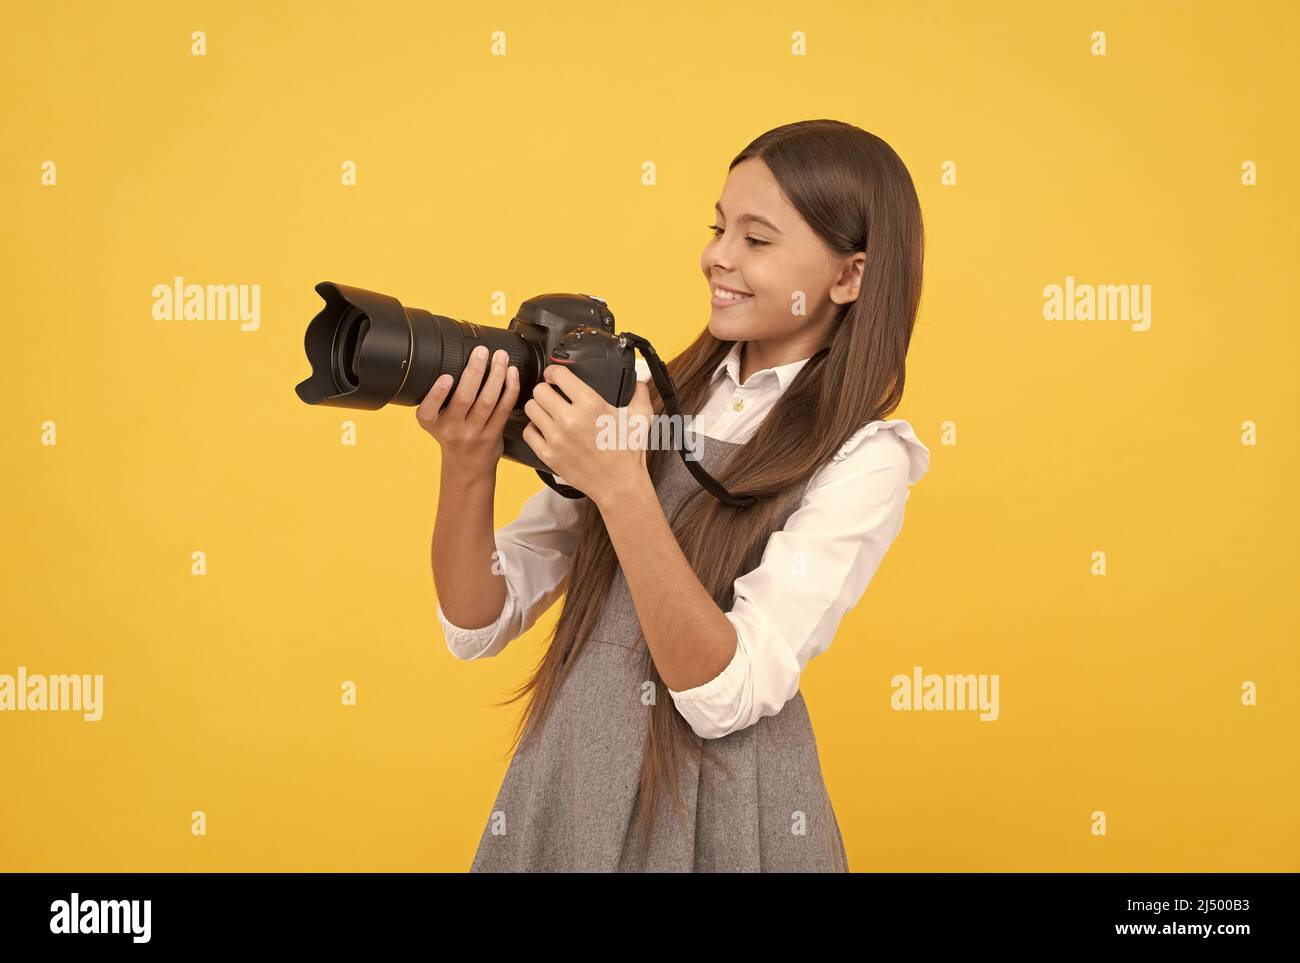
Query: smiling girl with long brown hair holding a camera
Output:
[[416, 120, 930, 872]]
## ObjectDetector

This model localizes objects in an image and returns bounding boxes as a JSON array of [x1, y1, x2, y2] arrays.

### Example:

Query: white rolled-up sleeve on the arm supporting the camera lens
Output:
[[437, 486, 582, 659]]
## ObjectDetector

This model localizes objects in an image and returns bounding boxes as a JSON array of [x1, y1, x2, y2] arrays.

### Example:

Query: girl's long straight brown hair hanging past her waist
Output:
[[488, 120, 924, 841]]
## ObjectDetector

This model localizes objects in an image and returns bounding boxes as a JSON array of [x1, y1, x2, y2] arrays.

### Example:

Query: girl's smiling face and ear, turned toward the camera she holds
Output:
[[699, 157, 866, 366]]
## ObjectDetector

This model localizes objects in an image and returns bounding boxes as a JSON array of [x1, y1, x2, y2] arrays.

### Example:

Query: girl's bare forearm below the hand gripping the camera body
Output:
[[598, 476, 736, 691]]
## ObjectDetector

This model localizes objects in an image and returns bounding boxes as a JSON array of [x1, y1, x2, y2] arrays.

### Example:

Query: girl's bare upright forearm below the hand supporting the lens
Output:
[[430, 463, 506, 629]]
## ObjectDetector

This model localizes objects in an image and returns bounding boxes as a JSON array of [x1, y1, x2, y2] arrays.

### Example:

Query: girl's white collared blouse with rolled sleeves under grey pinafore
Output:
[[438, 342, 930, 738]]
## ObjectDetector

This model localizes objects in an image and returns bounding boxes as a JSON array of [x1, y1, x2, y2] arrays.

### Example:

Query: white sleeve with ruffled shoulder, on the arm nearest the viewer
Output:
[[668, 420, 930, 738]]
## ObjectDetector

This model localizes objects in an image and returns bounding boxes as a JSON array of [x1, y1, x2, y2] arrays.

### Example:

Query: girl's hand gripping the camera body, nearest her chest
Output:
[[523, 364, 654, 506]]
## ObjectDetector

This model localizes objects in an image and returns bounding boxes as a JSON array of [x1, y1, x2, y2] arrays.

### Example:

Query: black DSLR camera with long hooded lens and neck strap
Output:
[[295, 281, 753, 506]]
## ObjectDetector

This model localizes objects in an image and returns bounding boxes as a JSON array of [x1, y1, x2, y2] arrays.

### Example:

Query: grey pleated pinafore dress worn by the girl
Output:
[[471, 437, 849, 872]]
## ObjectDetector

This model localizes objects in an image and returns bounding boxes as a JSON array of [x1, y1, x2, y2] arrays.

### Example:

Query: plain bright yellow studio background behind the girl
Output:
[[0, 0, 1300, 871]]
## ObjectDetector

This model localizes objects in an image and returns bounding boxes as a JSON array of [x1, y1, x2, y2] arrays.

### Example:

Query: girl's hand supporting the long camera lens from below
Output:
[[415, 344, 519, 476]]
